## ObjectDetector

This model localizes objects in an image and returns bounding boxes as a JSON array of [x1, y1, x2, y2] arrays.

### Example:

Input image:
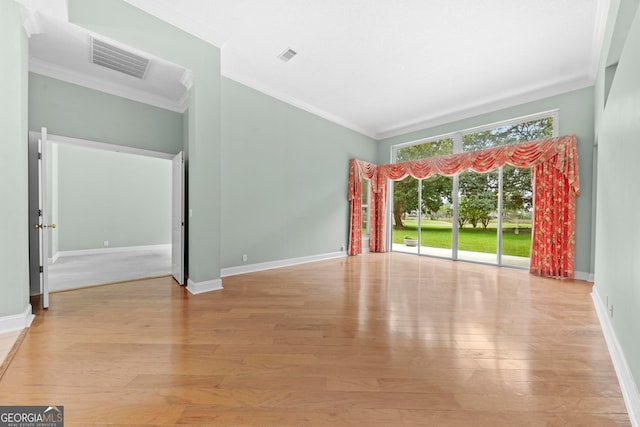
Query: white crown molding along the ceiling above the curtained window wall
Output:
[[375, 75, 595, 140]]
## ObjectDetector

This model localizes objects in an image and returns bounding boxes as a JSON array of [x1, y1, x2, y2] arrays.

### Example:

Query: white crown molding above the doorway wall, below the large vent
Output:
[[29, 57, 185, 113]]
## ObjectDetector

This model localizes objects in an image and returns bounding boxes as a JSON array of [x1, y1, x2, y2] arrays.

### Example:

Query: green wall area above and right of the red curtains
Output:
[[378, 87, 594, 274]]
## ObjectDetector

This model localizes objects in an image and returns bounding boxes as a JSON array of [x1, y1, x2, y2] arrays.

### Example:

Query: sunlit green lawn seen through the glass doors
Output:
[[392, 219, 531, 257]]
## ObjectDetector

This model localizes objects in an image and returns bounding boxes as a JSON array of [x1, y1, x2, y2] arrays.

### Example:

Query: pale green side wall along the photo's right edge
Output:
[[595, 2, 640, 392]]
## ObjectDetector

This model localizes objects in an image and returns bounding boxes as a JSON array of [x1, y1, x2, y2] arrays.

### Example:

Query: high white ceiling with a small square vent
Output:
[[21, 0, 609, 138]]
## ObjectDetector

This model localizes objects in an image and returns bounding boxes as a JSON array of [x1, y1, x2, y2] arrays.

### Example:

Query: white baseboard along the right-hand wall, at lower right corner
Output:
[[591, 288, 640, 427]]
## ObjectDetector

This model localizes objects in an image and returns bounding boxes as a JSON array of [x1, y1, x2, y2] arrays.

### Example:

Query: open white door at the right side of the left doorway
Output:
[[171, 151, 184, 285]]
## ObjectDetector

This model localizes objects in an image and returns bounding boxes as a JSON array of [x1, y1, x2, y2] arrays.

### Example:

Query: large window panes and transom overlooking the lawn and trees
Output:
[[391, 111, 558, 267]]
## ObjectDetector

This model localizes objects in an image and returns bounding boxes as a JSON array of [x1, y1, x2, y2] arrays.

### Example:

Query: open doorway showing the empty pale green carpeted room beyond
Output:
[[30, 134, 184, 307]]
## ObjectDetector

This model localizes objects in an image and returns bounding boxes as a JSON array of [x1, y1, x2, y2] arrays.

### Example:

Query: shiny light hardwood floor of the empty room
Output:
[[0, 254, 630, 427]]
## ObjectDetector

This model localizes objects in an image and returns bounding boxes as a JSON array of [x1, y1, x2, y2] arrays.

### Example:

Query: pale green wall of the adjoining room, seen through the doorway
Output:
[[55, 144, 171, 252]]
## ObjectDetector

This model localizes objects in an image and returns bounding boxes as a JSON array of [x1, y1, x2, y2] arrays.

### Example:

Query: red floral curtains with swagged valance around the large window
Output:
[[349, 135, 580, 277]]
